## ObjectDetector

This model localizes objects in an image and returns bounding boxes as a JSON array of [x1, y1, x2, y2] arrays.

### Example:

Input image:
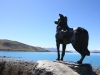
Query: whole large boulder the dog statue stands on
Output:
[[32, 60, 97, 75]]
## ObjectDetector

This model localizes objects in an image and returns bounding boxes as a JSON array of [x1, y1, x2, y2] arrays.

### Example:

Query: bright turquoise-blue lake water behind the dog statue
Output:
[[0, 51, 100, 67]]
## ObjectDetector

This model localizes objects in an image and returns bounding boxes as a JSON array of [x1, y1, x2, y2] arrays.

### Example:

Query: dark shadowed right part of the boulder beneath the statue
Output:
[[55, 61, 93, 75]]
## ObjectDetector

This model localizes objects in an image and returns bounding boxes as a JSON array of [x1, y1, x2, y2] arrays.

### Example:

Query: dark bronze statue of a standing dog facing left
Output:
[[54, 14, 90, 64]]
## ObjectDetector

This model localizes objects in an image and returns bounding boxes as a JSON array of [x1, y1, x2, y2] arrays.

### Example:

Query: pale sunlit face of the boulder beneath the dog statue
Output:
[[32, 60, 79, 75]]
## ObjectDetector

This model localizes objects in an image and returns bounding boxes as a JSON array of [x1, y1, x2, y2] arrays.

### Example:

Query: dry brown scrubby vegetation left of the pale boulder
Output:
[[0, 60, 34, 75]]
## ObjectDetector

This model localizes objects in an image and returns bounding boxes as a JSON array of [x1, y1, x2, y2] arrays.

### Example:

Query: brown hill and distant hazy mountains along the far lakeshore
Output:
[[0, 39, 100, 53]]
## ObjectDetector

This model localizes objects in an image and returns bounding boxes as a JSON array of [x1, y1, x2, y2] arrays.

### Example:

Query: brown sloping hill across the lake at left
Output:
[[0, 40, 48, 52]]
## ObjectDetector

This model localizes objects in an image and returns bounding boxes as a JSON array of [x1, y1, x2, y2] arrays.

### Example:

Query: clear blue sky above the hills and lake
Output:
[[0, 0, 100, 50]]
